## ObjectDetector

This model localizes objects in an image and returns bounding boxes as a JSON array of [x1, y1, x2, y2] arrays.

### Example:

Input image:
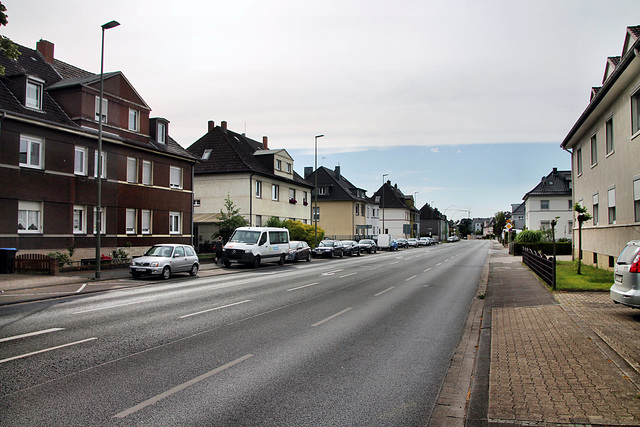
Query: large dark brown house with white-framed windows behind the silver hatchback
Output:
[[0, 40, 196, 260]]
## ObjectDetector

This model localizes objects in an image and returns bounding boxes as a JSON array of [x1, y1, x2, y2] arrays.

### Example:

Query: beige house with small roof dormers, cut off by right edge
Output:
[[562, 26, 640, 268]]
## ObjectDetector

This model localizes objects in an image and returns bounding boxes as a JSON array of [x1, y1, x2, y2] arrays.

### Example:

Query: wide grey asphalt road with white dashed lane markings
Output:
[[0, 241, 490, 426]]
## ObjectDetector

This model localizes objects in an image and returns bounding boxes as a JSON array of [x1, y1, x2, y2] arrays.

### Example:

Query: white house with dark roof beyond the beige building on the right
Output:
[[522, 168, 573, 239]]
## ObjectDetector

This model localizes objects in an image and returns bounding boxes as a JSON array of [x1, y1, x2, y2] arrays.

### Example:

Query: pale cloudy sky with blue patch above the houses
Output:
[[0, 0, 640, 219]]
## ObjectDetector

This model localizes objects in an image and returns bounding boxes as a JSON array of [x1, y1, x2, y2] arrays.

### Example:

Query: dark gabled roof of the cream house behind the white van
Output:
[[187, 126, 309, 187]]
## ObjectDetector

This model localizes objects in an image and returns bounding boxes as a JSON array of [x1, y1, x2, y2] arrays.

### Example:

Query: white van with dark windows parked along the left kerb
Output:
[[222, 227, 289, 268]]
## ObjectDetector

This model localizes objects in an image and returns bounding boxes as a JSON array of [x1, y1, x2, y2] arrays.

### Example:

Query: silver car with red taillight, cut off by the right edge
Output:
[[609, 240, 640, 308]]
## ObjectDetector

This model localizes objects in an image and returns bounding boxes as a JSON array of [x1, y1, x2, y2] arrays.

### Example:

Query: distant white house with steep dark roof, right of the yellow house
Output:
[[374, 181, 420, 237]]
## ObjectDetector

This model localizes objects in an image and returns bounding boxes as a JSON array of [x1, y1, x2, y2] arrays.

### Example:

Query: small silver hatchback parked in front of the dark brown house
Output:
[[129, 243, 200, 280]]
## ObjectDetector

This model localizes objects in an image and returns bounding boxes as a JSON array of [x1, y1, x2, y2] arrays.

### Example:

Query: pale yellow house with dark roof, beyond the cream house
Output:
[[304, 166, 379, 240]]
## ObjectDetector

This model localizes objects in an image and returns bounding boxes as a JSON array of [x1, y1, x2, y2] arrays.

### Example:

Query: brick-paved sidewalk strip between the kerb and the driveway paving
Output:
[[487, 246, 640, 426]]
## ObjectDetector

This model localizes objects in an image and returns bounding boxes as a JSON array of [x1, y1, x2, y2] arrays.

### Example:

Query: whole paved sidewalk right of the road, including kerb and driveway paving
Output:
[[430, 243, 640, 427]]
